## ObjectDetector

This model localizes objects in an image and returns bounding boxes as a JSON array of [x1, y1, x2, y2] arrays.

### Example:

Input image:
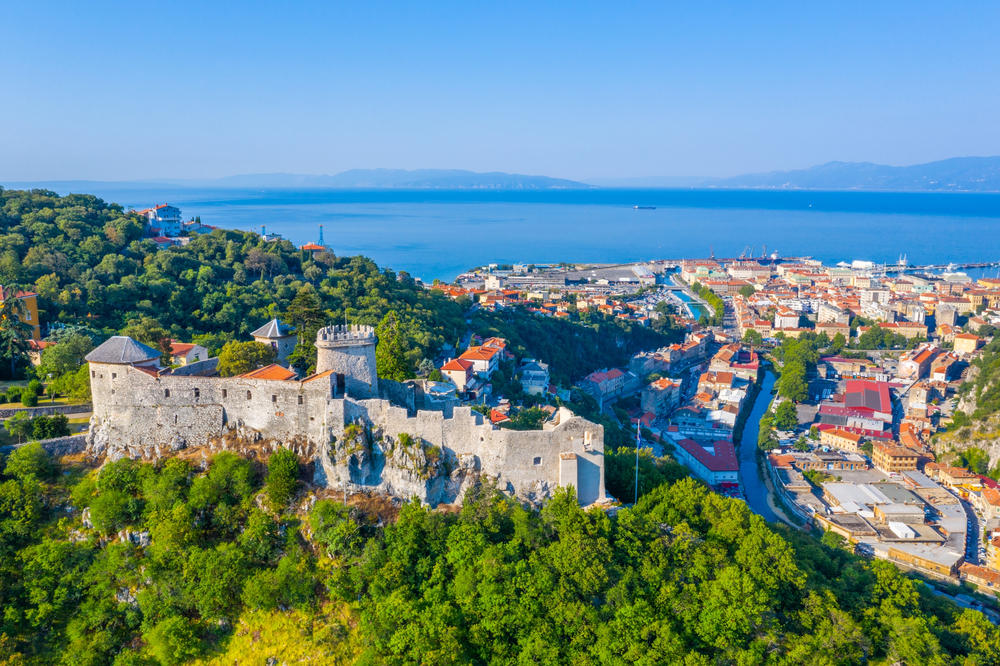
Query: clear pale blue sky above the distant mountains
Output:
[[0, 0, 1000, 182]]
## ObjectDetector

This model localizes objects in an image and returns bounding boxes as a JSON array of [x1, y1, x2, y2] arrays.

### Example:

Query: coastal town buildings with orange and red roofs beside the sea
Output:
[[5, 204, 1000, 616]]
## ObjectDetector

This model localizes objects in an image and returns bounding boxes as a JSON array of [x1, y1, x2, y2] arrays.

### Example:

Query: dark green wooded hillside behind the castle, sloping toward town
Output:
[[0, 188, 678, 385]]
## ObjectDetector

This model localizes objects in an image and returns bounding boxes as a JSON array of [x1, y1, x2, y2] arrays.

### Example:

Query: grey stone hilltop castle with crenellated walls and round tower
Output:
[[87, 322, 607, 506]]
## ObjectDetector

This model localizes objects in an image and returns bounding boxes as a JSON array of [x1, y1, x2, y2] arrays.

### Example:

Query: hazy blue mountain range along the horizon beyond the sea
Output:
[[8, 157, 1000, 192]]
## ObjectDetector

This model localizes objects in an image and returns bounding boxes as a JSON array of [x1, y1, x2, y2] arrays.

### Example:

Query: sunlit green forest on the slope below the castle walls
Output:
[[0, 446, 1000, 665]]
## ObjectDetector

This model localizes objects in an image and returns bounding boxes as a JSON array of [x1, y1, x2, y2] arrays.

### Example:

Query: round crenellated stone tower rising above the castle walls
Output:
[[316, 326, 378, 398]]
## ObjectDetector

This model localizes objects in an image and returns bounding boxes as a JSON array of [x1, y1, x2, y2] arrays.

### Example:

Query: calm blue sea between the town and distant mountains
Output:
[[27, 187, 1000, 280]]
